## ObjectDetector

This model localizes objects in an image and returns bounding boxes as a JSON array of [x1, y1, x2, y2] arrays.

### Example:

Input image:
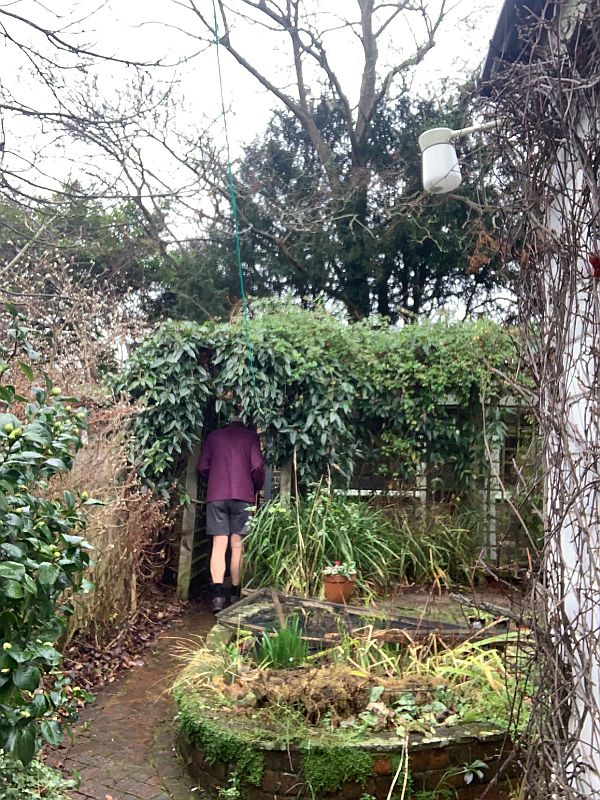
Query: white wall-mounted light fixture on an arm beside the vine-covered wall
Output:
[[419, 120, 499, 194]]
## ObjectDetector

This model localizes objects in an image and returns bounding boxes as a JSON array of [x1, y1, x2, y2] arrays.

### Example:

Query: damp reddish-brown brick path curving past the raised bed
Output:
[[48, 607, 214, 800]]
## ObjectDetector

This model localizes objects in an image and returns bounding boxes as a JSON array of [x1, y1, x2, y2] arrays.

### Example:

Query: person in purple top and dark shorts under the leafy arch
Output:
[[198, 416, 265, 612]]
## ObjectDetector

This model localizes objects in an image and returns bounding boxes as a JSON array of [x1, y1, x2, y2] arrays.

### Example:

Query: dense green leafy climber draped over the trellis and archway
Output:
[[116, 304, 515, 490]]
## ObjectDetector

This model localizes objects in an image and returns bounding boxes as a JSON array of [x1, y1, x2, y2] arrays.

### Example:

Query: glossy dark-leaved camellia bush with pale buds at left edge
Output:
[[0, 310, 94, 764]]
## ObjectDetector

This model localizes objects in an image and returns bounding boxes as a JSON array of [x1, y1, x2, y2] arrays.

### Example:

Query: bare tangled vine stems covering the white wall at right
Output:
[[480, 0, 600, 800]]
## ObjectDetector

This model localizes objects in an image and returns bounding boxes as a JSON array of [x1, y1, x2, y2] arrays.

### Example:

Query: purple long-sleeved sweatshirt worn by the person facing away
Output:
[[198, 422, 265, 503]]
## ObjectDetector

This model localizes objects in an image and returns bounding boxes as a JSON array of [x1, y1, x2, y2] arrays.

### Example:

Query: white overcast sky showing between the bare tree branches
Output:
[[0, 0, 502, 208]]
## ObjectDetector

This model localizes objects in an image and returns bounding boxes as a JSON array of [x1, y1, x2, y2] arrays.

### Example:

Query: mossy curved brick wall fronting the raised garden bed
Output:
[[179, 725, 519, 800]]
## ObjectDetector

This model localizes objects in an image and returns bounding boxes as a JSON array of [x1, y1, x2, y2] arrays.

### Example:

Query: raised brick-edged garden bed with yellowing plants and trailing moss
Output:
[[175, 626, 518, 800]]
